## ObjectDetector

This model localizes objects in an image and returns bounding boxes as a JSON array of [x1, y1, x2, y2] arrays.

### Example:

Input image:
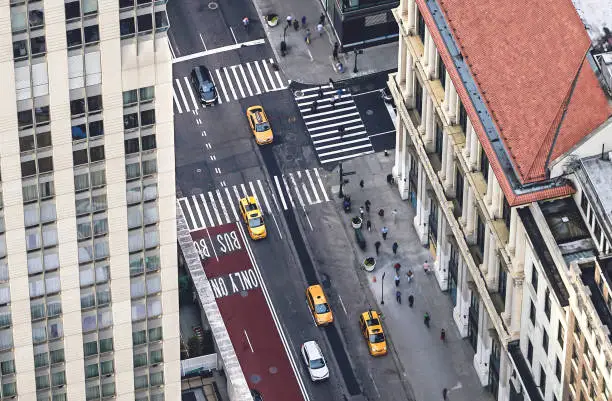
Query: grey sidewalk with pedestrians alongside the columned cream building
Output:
[[328, 152, 493, 401]]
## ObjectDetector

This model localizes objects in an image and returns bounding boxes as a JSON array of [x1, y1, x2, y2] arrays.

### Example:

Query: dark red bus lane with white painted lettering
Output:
[[191, 224, 305, 401]]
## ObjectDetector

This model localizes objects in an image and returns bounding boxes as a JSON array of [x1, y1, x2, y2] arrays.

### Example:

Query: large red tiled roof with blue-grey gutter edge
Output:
[[417, 0, 611, 205]]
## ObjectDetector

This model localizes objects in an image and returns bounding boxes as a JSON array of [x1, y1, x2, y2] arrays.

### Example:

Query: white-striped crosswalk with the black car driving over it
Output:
[[173, 59, 288, 114]]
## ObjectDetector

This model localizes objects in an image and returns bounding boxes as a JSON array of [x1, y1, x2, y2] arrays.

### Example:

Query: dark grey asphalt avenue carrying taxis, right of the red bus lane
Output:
[[168, 0, 406, 401]]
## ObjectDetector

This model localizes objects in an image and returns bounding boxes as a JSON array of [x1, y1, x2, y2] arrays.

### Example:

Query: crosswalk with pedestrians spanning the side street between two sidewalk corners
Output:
[[295, 85, 374, 164]]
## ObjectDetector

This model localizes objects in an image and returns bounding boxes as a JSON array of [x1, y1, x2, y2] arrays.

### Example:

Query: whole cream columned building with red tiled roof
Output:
[[388, 0, 612, 401]]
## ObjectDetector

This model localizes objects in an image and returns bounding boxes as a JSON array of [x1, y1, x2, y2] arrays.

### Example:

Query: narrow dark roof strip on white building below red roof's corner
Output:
[[518, 207, 569, 307]]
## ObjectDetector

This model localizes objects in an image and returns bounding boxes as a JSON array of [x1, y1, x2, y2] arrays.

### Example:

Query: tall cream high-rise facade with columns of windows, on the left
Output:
[[0, 0, 180, 401]]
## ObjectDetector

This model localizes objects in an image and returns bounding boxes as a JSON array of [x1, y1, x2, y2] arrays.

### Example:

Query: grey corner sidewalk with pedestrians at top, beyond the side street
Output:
[[253, 0, 398, 85]]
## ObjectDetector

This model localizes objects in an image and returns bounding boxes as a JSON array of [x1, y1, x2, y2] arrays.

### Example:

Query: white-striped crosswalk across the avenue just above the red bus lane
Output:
[[177, 168, 330, 231]]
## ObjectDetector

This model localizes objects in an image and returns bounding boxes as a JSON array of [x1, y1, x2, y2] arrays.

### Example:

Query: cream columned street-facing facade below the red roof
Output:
[[388, 0, 612, 401]]
